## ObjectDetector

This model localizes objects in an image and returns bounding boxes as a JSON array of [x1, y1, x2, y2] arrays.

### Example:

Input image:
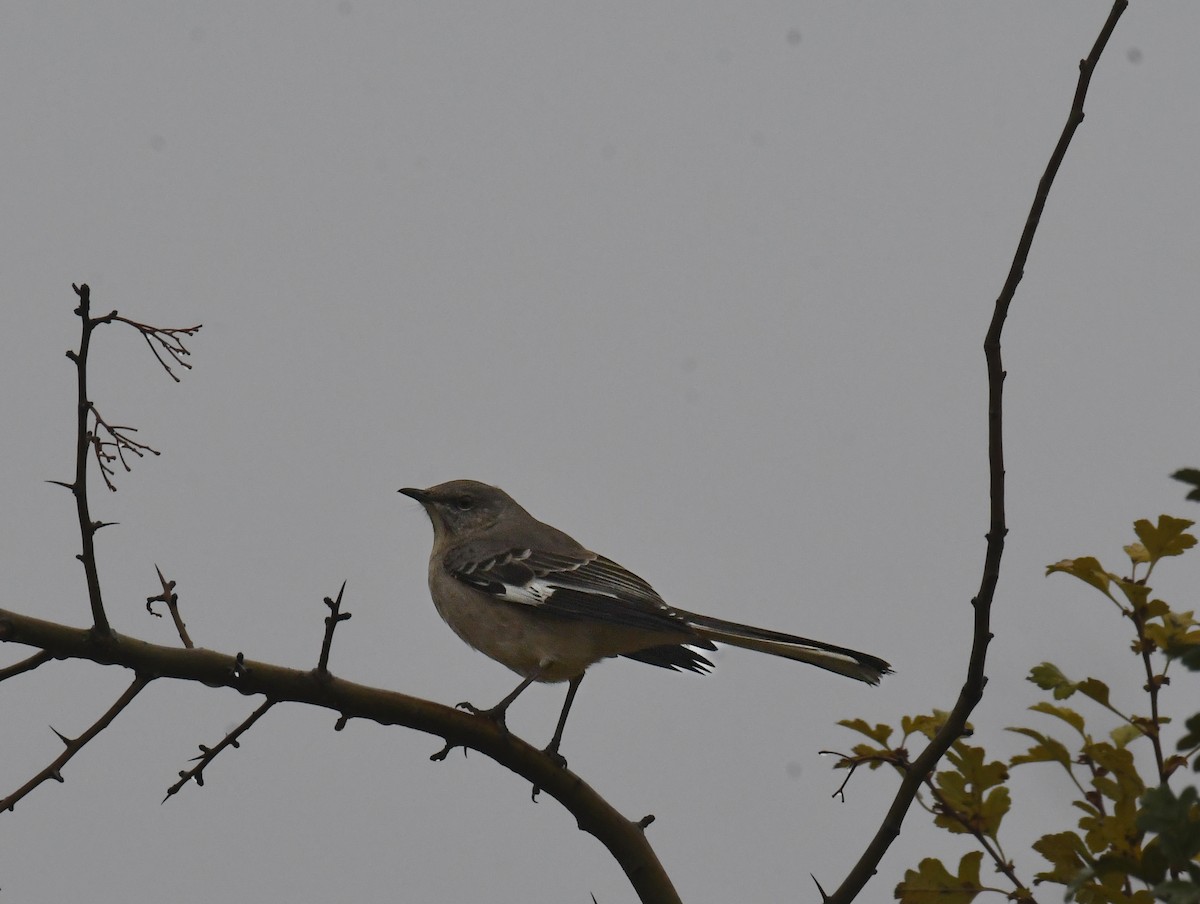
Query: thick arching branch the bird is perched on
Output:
[[0, 609, 679, 904]]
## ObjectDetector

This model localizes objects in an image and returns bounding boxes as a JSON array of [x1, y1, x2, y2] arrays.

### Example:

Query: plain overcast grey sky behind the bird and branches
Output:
[[0, 0, 1200, 904]]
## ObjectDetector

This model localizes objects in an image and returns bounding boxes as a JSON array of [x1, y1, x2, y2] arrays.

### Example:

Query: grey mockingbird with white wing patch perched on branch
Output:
[[400, 480, 892, 762]]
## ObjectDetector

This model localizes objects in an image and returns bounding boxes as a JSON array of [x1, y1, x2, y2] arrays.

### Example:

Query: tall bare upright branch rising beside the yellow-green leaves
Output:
[[828, 0, 1129, 904]]
